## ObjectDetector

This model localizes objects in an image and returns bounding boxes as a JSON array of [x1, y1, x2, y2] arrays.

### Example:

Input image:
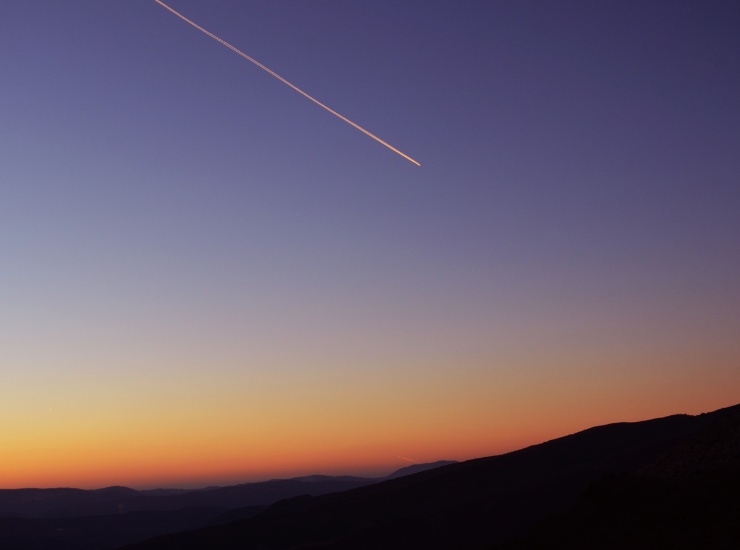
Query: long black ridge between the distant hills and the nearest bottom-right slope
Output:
[[124, 406, 740, 550]]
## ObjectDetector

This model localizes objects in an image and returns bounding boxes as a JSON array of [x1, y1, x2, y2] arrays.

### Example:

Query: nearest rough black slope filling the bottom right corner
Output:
[[500, 408, 740, 550]]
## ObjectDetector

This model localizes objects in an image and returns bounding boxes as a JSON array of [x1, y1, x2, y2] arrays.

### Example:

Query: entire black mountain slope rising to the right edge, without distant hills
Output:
[[118, 405, 740, 550]]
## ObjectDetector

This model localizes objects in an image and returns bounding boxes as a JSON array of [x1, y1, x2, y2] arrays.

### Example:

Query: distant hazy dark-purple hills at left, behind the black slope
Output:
[[0, 461, 451, 550]]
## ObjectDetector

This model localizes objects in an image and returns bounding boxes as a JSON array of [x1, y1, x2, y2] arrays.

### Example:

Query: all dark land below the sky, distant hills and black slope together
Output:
[[0, 405, 740, 550]]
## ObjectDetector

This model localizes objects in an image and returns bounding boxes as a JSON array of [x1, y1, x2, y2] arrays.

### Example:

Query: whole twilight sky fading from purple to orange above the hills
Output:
[[0, 0, 740, 488]]
